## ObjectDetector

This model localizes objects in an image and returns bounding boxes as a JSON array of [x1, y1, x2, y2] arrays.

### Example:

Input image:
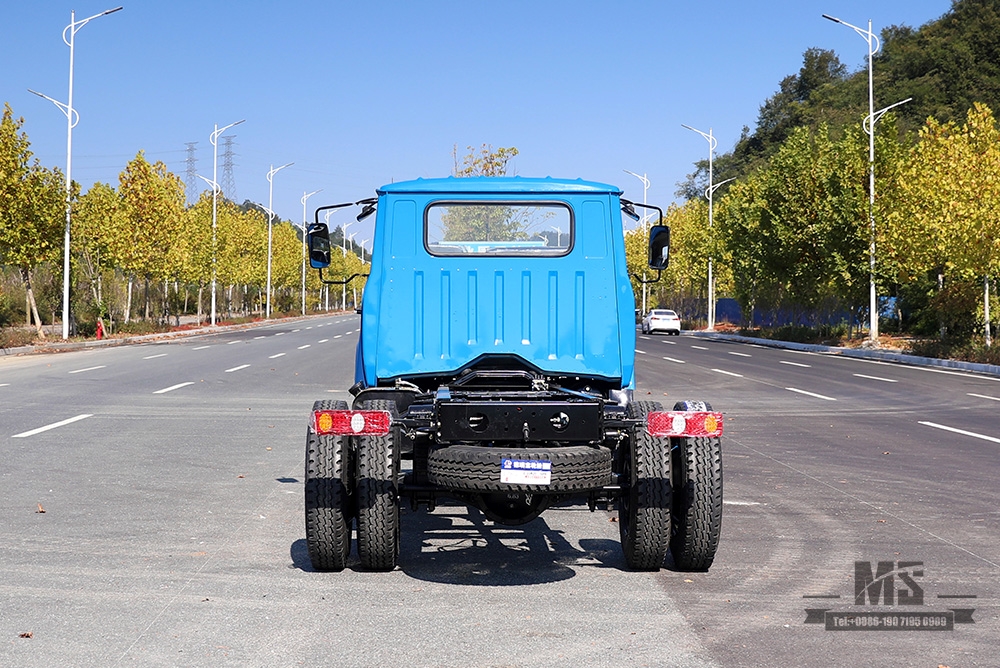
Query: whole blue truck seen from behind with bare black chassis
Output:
[[305, 177, 722, 570]]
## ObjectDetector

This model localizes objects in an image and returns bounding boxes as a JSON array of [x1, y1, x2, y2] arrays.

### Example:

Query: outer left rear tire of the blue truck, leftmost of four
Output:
[[305, 401, 354, 571]]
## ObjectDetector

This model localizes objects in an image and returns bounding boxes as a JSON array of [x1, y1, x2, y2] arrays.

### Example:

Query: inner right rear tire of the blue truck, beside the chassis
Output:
[[618, 401, 670, 571]]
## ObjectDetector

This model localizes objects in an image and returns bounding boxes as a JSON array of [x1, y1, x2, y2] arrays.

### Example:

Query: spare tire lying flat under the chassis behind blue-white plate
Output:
[[427, 445, 611, 494]]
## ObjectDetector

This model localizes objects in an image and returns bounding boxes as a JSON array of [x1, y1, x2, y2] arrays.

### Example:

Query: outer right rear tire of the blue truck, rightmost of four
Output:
[[670, 401, 722, 571]]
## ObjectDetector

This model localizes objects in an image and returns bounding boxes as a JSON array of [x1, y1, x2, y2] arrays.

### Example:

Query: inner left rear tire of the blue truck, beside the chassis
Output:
[[355, 400, 400, 571]]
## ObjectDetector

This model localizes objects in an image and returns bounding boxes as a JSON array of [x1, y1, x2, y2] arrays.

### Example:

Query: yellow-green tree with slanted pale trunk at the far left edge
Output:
[[0, 103, 66, 338]]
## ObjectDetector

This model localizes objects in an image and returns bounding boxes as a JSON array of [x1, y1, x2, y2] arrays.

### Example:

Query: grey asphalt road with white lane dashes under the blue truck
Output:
[[0, 316, 1000, 668]]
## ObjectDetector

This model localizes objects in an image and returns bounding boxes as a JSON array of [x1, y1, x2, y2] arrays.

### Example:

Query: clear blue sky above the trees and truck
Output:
[[0, 0, 951, 239]]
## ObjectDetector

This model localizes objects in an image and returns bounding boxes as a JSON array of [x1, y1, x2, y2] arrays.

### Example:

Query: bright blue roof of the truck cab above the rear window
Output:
[[377, 176, 622, 195]]
